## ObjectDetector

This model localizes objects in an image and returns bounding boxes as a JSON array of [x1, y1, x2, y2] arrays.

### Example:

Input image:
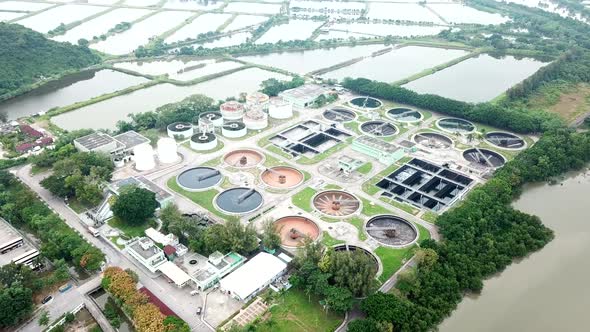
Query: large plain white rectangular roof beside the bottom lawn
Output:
[[220, 252, 287, 302]]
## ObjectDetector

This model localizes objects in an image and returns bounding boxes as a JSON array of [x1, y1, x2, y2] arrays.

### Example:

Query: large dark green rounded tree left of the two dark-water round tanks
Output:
[[111, 186, 158, 225]]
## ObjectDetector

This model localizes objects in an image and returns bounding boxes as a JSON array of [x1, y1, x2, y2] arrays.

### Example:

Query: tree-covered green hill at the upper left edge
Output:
[[0, 23, 100, 98]]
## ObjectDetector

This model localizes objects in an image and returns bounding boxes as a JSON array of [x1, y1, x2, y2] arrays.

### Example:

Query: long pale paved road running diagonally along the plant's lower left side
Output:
[[16, 165, 211, 331]]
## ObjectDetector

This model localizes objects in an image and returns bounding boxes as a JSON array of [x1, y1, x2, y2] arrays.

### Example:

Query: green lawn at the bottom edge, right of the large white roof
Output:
[[255, 288, 343, 332]]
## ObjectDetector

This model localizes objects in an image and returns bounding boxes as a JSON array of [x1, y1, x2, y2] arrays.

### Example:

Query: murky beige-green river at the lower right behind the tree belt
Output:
[[440, 170, 590, 332]]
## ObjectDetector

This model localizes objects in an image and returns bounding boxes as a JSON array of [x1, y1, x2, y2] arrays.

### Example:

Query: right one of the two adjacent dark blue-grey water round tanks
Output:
[[214, 187, 263, 215]]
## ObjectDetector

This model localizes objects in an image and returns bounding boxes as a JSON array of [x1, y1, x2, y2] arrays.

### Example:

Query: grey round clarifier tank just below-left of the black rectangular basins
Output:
[[365, 215, 418, 247]]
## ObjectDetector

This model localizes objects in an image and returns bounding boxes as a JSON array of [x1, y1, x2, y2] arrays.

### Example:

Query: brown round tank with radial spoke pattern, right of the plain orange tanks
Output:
[[312, 190, 361, 217]]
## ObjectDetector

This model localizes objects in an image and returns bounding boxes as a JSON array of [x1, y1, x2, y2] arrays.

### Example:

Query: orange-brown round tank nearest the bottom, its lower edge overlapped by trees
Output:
[[275, 216, 320, 248]]
